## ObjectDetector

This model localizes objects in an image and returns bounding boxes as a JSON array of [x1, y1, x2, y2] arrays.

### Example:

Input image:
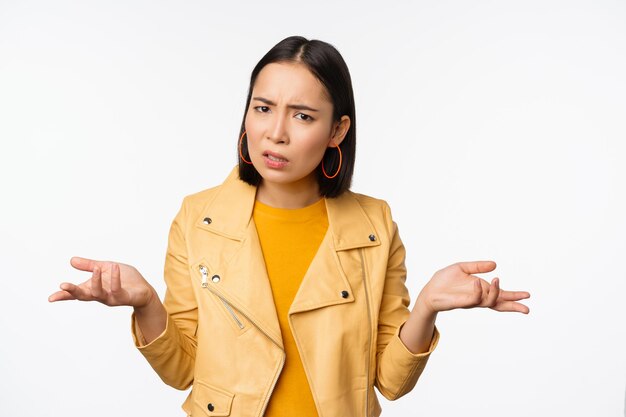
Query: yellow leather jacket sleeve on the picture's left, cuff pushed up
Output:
[[131, 200, 198, 390]]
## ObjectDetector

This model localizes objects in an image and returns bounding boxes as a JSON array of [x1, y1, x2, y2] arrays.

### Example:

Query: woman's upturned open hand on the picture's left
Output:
[[48, 257, 158, 308]]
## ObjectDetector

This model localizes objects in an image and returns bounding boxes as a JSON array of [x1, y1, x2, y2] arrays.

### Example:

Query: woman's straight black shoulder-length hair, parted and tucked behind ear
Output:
[[237, 36, 356, 198]]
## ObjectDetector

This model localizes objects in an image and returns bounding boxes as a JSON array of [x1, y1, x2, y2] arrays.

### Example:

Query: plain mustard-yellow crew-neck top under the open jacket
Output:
[[253, 198, 328, 417]]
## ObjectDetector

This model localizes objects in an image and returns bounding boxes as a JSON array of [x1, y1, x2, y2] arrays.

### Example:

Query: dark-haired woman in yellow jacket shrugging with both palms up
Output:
[[49, 36, 529, 416]]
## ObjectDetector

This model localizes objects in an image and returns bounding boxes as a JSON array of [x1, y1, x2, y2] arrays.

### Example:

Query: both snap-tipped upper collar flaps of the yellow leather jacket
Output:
[[196, 166, 380, 251]]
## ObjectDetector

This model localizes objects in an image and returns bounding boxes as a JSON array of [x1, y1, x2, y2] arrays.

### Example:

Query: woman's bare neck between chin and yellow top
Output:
[[256, 180, 320, 209]]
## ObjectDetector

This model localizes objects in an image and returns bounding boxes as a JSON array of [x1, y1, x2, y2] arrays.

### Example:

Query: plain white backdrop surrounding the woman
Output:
[[0, 0, 626, 417]]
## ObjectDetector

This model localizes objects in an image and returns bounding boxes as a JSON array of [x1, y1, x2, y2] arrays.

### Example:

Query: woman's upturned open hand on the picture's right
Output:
[[418, 261, 530, 314]]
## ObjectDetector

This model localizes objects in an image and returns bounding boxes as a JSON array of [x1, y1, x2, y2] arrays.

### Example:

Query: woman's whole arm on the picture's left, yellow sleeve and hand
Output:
[[48, 197, 198, 389]]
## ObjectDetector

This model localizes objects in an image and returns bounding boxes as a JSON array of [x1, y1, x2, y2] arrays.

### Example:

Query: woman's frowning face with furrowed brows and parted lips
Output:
[[245, 63, 350, 193]]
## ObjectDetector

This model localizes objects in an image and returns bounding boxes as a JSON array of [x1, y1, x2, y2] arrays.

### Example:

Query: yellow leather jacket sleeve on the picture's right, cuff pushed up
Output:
[[375, 204, 439, 400]]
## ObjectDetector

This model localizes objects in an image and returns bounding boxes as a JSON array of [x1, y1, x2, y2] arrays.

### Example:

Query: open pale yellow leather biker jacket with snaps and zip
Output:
[[131, 168, 439, 417]]
